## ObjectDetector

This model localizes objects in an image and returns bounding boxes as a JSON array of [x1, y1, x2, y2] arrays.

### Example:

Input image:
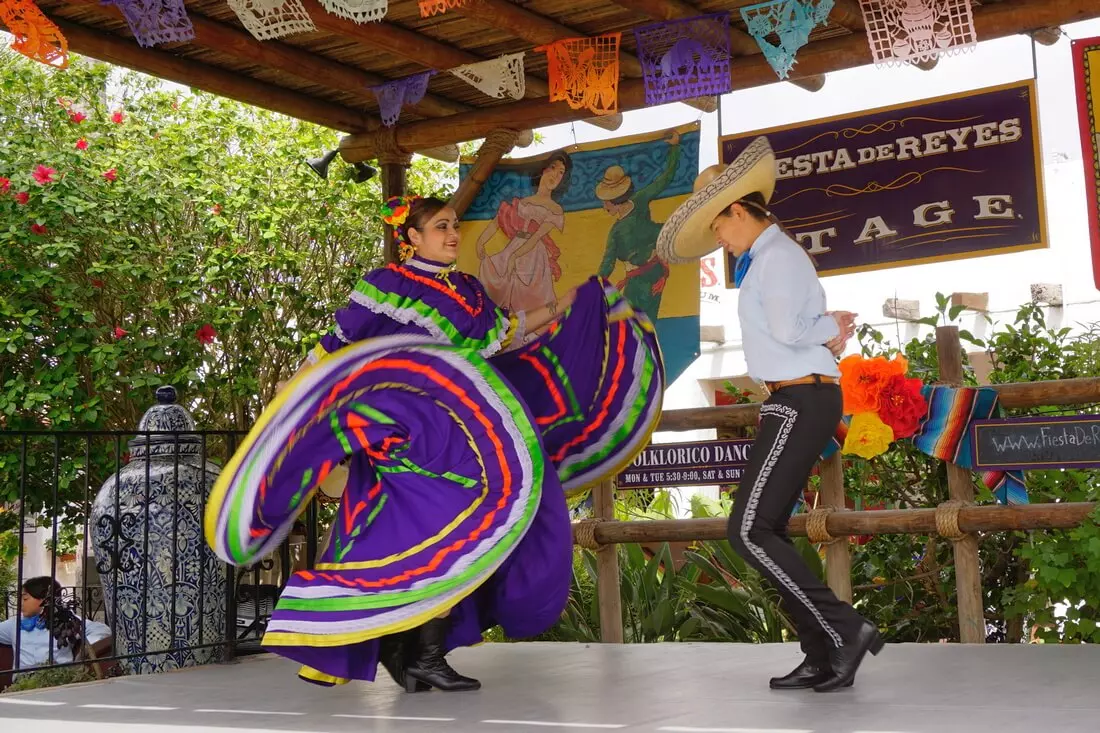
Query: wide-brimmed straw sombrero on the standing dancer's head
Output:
[[657, 138, 776, 264]]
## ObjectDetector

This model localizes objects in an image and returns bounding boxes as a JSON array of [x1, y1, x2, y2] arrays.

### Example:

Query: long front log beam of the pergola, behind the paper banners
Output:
[[341, 0, 1100, 162]]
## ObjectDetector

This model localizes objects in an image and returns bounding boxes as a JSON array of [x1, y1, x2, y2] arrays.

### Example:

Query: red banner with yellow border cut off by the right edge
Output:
[[1073, 37, 1100, 288]]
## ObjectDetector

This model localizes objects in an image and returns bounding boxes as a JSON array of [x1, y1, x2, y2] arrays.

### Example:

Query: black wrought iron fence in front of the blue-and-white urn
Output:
[[0, 430, 318, 689]]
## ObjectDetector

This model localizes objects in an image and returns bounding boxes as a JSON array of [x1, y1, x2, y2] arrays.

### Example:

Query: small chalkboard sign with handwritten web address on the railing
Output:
[[971, 415, 1100, 471]]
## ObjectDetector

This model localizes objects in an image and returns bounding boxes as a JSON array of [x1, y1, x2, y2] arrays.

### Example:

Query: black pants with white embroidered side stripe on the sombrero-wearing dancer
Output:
[[728, 384, 862, 663]]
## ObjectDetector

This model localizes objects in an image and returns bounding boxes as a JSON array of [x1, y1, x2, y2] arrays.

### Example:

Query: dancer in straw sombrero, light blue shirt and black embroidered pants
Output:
[[658, 138, 882, 692]]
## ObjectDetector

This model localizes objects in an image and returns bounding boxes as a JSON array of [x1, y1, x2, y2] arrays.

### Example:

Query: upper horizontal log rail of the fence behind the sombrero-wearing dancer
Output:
[[657, 376, 1100, 431]]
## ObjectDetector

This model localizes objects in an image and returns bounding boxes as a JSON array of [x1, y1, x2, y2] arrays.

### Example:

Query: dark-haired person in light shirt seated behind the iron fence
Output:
[[0, 577, 113, 669]]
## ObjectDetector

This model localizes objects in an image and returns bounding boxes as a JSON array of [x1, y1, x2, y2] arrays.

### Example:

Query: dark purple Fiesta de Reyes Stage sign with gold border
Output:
[[719, 80, 1047, 287]]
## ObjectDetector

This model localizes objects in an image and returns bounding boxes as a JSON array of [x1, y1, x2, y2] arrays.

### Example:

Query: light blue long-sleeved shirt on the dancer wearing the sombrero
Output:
[[737, 225, 840, 382]]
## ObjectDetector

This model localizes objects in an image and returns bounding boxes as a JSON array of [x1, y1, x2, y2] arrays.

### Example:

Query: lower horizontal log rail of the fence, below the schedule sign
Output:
[[573, 502, 1097, 545]]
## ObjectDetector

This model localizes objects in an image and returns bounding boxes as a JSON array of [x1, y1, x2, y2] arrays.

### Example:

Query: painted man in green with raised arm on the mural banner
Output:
[[596, 132, 680, 319]]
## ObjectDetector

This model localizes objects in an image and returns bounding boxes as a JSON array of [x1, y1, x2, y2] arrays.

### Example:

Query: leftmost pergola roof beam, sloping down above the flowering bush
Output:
[[51, 17, 373, 132]]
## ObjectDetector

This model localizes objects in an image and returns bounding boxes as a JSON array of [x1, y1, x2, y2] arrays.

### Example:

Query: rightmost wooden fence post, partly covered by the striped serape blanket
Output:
[[936, 326, 986, 644]]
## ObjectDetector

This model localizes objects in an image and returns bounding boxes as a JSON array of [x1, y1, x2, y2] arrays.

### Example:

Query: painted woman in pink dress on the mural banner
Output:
[[477, 151, 573, 310]]
